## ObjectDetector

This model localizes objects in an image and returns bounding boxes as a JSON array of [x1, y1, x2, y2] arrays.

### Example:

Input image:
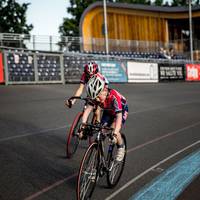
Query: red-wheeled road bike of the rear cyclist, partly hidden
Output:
[[66, 96, 96, 158]]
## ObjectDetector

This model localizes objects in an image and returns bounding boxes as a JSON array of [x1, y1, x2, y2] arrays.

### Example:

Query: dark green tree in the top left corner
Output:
[[0, 0, 33, 34]]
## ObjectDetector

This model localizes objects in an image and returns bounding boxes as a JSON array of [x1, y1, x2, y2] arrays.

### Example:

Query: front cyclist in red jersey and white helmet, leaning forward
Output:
[[80, 74, 128, 161]]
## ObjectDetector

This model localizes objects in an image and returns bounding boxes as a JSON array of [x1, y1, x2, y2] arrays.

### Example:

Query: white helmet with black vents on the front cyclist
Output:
[[86, 73, 105, 99]]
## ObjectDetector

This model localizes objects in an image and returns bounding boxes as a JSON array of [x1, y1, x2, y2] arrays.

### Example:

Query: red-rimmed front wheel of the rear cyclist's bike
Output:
[[66, 112, 83, 158]]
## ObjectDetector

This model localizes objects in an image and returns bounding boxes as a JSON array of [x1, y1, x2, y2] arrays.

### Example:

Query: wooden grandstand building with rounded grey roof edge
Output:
[[80, 2, 200, 56]]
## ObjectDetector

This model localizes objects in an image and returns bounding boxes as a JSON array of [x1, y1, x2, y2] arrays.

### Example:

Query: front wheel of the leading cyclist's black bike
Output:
[[76, 142, 99, 200]]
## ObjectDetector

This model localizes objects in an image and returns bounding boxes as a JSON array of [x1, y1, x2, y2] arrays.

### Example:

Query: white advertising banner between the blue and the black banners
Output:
[[127, 62, 158, 83]]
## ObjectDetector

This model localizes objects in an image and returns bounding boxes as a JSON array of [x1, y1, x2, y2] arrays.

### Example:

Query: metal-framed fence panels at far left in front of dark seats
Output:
[[4, 51, 64, 84]]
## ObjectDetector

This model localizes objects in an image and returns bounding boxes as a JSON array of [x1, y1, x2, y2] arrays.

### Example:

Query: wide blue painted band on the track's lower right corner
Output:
[[129, 150, 200, 200]]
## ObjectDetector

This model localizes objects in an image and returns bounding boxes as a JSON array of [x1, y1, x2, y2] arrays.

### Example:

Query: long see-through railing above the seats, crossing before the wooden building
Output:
[[0, 33, 200, 58]]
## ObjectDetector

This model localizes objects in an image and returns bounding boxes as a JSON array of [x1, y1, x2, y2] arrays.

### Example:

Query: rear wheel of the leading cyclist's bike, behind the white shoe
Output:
[[107, 134, 127, 188]]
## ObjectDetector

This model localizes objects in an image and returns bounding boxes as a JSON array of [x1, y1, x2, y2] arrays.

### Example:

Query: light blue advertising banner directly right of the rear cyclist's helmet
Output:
[[97, 61, 127, 83]]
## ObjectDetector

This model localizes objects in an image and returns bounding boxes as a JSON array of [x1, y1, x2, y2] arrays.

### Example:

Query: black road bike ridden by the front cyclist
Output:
[[76, 123, 127, 200]]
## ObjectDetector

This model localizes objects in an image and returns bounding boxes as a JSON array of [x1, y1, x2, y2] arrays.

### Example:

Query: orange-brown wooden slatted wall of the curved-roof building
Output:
[[81, 3, 200, 50]]
